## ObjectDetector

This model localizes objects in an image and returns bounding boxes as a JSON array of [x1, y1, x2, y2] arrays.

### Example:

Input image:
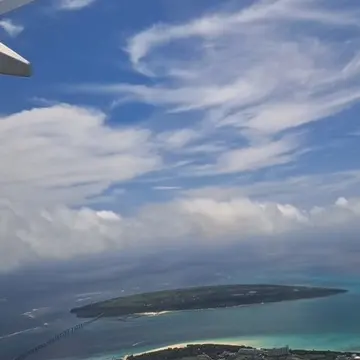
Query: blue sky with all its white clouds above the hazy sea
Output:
[[0, 0, 360, 271]]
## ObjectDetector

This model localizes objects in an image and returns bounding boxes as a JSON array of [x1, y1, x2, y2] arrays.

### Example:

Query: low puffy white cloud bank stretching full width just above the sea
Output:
[[0, 197, 360, 271]]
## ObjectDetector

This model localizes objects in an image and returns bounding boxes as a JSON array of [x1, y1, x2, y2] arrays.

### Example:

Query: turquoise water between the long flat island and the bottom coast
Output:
[[75, 279, 360, 359]]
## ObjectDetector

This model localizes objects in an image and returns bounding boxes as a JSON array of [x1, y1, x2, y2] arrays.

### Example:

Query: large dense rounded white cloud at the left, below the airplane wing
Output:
[[0, 104, 162, 204]]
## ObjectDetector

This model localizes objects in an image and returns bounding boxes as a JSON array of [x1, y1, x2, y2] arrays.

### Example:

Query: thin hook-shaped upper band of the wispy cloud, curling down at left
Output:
[[128, 0, 358, 70]]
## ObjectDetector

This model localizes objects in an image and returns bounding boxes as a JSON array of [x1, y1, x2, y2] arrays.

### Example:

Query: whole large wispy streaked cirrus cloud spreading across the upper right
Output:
[[72, 0, 360, 179]]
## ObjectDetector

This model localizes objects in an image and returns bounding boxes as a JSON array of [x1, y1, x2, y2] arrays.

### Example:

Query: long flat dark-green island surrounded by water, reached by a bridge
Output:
[[70, 285, 346, 318]]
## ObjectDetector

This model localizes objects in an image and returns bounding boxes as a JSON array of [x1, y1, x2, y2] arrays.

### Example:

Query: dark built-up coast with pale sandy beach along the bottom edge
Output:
[[123, 344, 360, 360]]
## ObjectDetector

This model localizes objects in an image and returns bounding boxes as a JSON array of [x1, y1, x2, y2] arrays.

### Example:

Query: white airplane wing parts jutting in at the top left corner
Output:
[[0, 0, 33, 76]]
